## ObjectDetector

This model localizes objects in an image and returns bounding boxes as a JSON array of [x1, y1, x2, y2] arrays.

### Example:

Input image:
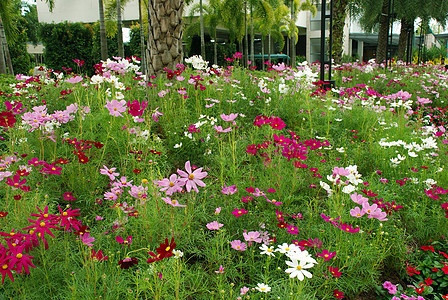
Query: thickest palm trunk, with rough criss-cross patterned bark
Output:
[[148, 0, 184, 75]]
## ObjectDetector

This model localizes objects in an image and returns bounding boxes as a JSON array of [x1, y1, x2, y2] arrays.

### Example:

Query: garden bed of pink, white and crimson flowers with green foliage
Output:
[[0, 53, 448, 300]]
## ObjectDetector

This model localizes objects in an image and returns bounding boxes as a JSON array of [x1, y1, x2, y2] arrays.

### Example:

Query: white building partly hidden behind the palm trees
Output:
[[36, 0, 430, 62]]
